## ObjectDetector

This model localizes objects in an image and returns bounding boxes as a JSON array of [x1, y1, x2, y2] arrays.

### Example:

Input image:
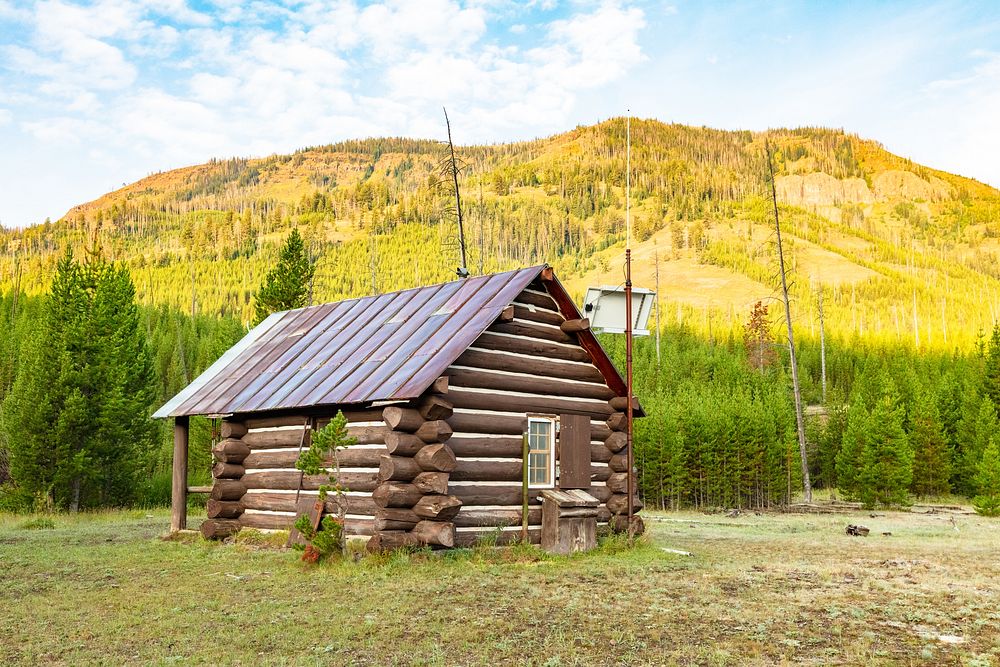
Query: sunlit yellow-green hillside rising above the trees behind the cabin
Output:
[[0, 119, 1000, 347]]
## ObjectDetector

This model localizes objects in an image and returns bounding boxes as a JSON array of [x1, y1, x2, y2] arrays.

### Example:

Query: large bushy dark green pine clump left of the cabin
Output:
[[3, 251, 155, 511]]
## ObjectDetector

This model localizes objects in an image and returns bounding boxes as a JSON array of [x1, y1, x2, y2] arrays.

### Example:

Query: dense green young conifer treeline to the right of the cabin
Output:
[[616, 327, 1000, 508]]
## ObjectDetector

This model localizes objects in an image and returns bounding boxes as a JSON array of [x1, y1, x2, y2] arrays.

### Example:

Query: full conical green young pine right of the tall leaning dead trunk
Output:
[[858, 392, 913, 507]]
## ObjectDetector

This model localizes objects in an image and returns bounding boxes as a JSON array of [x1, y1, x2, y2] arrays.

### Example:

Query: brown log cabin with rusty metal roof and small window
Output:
[[154, 265, 642, 549]]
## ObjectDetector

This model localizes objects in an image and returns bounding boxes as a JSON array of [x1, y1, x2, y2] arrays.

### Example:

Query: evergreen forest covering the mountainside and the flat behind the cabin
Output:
[[0, 119, 1000, 513]]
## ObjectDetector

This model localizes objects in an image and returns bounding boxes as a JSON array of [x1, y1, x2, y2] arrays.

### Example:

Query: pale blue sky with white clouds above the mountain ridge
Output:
[[0, 0, 1000, 227]]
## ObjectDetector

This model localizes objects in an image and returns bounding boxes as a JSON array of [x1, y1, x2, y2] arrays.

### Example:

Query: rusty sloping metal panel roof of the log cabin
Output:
[[153, 265, 546, 418]]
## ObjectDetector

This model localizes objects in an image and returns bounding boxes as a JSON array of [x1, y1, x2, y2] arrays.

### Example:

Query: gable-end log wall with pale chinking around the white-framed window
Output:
[[445, 281, 641, 545]]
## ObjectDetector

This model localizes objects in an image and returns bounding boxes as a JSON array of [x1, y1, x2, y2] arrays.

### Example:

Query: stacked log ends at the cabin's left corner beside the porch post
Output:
[[201, 421, 250, 540]]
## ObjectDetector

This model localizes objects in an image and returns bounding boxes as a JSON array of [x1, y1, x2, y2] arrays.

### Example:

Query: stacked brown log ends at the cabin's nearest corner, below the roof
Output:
[[368, 392, 462, 551]]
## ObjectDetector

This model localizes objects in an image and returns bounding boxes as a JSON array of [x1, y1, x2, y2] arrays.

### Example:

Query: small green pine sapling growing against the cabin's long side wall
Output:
[[295, 411, 358, 563]]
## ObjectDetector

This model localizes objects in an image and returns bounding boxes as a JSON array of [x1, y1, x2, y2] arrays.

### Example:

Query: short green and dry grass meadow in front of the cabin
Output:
[[0, 511, 1000, 666]]
